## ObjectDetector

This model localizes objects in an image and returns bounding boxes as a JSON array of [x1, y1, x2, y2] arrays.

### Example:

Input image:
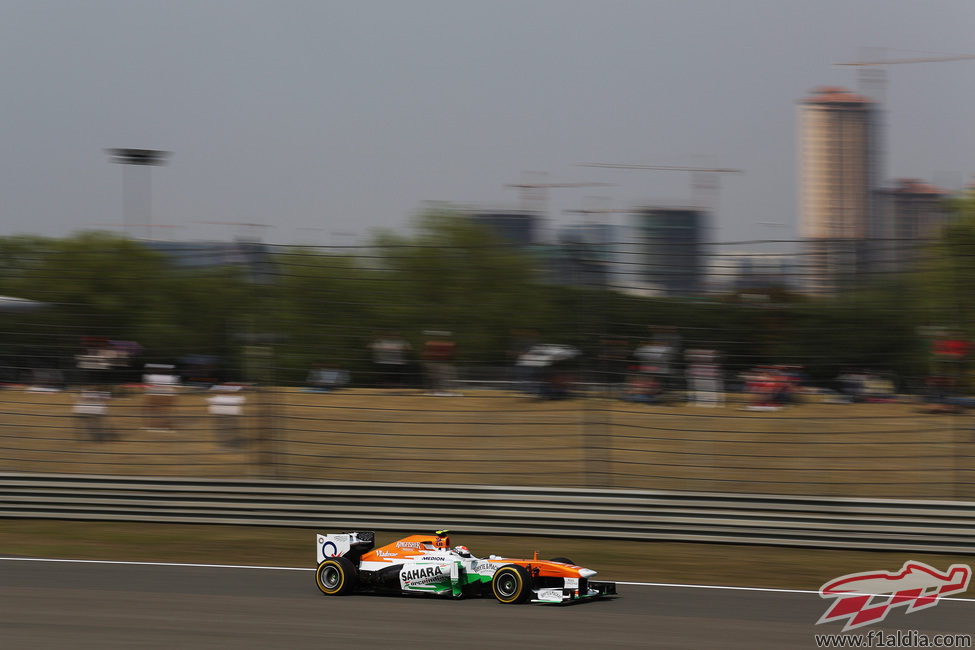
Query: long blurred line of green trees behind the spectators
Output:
[[0, 199, 975, 383]]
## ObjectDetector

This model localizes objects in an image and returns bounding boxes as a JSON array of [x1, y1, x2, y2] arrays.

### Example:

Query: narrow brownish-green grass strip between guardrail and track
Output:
[[0, 519, 975, 596]]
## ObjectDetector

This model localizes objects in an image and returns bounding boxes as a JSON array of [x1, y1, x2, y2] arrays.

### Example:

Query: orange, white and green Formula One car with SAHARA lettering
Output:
[[315, 530, 616, 604]]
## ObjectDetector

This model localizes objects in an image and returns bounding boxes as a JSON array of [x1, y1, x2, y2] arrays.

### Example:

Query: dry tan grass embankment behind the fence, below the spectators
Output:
[[0, 389, 975, 498]]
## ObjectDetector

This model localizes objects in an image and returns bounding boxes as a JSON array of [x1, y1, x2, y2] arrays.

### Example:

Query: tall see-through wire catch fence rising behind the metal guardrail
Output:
[[0, 235, 975, 500]]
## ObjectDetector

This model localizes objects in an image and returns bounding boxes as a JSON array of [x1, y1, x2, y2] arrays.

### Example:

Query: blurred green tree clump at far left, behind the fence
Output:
[[0, 232, 254, 368]]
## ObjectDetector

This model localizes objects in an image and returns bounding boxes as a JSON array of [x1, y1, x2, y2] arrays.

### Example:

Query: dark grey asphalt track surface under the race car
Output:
[[0, 559, 975, 650]]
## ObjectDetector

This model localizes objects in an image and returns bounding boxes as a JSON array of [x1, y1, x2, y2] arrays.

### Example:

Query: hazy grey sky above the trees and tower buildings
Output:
[[0, 0, 975, 244]]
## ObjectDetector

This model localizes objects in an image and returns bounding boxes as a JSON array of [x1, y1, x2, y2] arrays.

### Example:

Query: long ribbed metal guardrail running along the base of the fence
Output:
[[0, 473, 975, 553]]
